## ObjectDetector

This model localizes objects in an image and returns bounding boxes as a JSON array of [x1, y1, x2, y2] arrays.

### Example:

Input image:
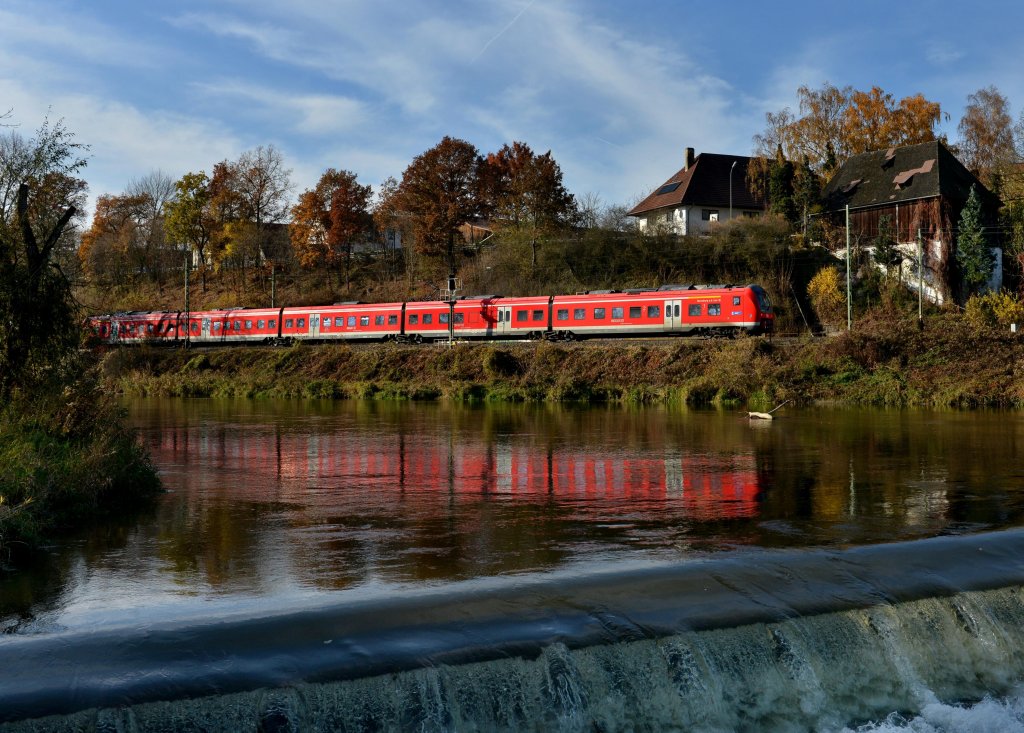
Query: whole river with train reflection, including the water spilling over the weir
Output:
[[0, 399, 1024, 731]]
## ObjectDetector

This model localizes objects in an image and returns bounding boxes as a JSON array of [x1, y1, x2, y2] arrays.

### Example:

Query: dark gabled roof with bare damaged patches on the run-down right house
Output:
[[821, 140, 994, 211]]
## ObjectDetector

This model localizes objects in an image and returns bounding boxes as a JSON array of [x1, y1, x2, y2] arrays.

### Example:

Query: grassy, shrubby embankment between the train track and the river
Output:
[[103, 313, 1024, 408]]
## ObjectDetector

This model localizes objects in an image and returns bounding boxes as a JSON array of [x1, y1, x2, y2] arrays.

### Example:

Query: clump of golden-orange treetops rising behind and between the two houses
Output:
[[751, 83, 942, 183]]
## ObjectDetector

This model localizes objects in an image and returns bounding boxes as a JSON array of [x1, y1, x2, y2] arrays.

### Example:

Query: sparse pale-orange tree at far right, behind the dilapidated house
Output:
[[956, 86, 1017, 190]]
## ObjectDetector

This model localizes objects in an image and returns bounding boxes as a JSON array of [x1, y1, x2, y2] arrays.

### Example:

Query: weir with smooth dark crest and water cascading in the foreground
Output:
[[6, 530, 1024, 731]]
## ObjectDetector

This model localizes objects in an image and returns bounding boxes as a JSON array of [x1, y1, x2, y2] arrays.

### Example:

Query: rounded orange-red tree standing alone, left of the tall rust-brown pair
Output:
[[290, 168, 373, 291]]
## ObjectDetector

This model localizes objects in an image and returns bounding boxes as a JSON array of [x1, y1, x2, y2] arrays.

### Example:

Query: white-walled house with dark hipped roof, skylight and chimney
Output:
[[629, 147, 765, 234]]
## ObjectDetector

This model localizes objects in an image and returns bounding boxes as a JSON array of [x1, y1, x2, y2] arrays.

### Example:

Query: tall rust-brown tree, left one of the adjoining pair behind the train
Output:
[[398, 136, 482, 273]]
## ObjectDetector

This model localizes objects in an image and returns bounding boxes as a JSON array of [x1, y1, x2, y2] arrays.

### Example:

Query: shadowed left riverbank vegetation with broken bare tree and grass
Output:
[[0, 118, 159, 563]]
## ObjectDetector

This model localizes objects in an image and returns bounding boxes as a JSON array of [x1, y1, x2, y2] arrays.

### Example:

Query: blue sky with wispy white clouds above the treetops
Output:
[[0, 0, 1024, 218]]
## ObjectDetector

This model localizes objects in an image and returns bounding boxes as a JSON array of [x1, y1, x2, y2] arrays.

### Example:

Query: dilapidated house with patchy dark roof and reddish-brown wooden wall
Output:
[[822, 140, 1001, 301]]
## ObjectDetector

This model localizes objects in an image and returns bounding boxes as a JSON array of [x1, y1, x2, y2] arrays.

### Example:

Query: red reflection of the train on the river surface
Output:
[[153, 428, 761, 520]]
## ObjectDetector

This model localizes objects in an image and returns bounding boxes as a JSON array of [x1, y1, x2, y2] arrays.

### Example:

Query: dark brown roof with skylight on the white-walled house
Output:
[[629, 153, 765, 216]]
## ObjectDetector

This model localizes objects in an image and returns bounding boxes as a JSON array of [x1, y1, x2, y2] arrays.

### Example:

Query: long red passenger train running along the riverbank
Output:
[[87, 285, 775, 345]]
